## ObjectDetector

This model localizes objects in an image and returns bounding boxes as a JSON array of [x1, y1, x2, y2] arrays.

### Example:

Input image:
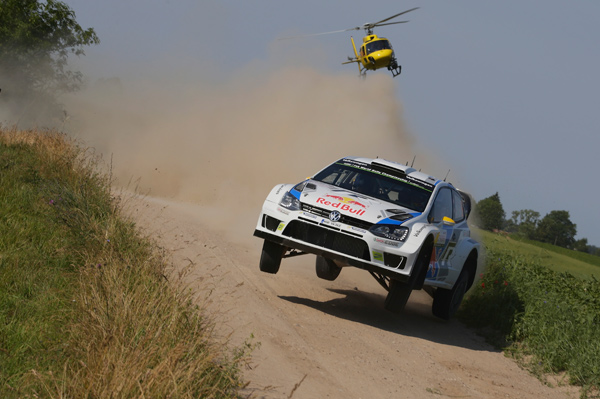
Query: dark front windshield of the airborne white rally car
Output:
[[313, 161, 433, 212]]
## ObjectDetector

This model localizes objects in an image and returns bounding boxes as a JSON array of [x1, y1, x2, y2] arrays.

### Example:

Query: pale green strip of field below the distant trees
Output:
[[476, 230, 600, 279]]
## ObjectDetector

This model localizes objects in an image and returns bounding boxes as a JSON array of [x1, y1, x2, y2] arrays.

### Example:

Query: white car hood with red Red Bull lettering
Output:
[[293, 180, 419, 224]]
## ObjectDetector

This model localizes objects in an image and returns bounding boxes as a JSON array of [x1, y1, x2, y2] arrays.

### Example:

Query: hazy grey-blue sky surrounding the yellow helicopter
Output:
[[66, 0, 600, 246]]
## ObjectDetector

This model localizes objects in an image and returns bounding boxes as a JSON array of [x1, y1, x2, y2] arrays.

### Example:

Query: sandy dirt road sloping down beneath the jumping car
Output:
[[128, 198, 578, 399]]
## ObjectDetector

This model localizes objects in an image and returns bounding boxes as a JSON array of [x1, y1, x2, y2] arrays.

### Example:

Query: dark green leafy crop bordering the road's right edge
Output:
[[458, 228, 600, 397]]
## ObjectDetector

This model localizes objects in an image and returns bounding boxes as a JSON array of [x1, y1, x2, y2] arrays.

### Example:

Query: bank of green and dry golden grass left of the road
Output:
[[0, 129, 249, 398]]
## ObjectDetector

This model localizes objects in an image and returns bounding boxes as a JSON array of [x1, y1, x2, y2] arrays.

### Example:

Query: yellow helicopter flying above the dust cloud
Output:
[[282, 7, 419, 77]]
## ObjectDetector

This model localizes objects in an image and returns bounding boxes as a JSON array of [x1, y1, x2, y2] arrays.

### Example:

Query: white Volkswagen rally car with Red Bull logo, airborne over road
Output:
[[254, 157, 479, 319]]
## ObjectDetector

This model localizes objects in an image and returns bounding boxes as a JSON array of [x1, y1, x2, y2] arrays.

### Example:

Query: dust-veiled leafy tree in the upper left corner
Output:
[[0, 0, 100, 123]]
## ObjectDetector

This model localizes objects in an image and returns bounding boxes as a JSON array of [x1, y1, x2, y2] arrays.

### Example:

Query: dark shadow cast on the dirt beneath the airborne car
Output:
[[279, 288, 500, 352]]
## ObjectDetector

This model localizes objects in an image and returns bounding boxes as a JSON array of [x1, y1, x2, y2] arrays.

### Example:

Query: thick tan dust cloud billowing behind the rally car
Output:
[[65, 67, 426, 239]]
